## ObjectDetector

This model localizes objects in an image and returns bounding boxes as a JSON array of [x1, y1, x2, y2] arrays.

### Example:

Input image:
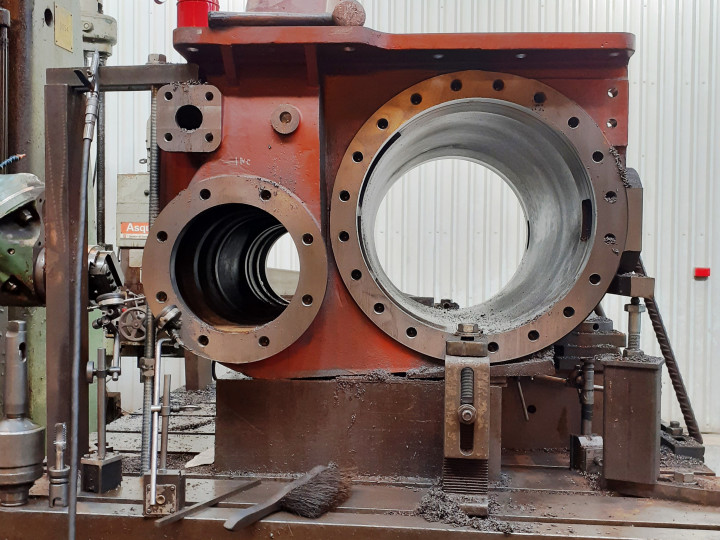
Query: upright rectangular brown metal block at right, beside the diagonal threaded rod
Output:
[[602, 356, 663, 484]]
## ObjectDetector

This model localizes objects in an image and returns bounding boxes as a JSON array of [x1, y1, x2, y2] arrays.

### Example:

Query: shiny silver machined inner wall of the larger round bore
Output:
[[358, 98, 592, 334]]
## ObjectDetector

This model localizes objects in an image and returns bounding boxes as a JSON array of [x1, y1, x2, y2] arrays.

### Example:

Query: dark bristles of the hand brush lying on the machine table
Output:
[[282, 463, 350, 519]]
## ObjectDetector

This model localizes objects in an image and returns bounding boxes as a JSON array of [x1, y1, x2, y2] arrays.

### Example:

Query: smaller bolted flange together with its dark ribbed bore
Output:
[[143, 175, 327, 364]]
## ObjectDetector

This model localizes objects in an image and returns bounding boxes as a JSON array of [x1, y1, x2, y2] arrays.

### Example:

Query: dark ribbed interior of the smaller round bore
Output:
[[172, 204, 296, 326]]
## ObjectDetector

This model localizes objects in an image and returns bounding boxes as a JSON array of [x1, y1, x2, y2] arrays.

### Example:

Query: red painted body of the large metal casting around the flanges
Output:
[[161, 27, 634, 378]]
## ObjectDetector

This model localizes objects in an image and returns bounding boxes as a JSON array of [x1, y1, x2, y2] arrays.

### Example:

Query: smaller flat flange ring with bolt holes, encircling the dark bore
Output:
[[143, 175, 328, 364]]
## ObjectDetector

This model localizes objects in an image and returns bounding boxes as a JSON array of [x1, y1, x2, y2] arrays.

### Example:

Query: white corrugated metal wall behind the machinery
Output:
[[105, 0, 720, 431]]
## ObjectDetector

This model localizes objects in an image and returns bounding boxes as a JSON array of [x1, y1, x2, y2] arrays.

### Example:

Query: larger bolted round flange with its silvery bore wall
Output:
[[330, 71, 627, 363]]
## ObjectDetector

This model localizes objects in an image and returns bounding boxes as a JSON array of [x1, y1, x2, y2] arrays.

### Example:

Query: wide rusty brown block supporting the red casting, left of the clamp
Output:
[[215, 377, 444, 478]]
